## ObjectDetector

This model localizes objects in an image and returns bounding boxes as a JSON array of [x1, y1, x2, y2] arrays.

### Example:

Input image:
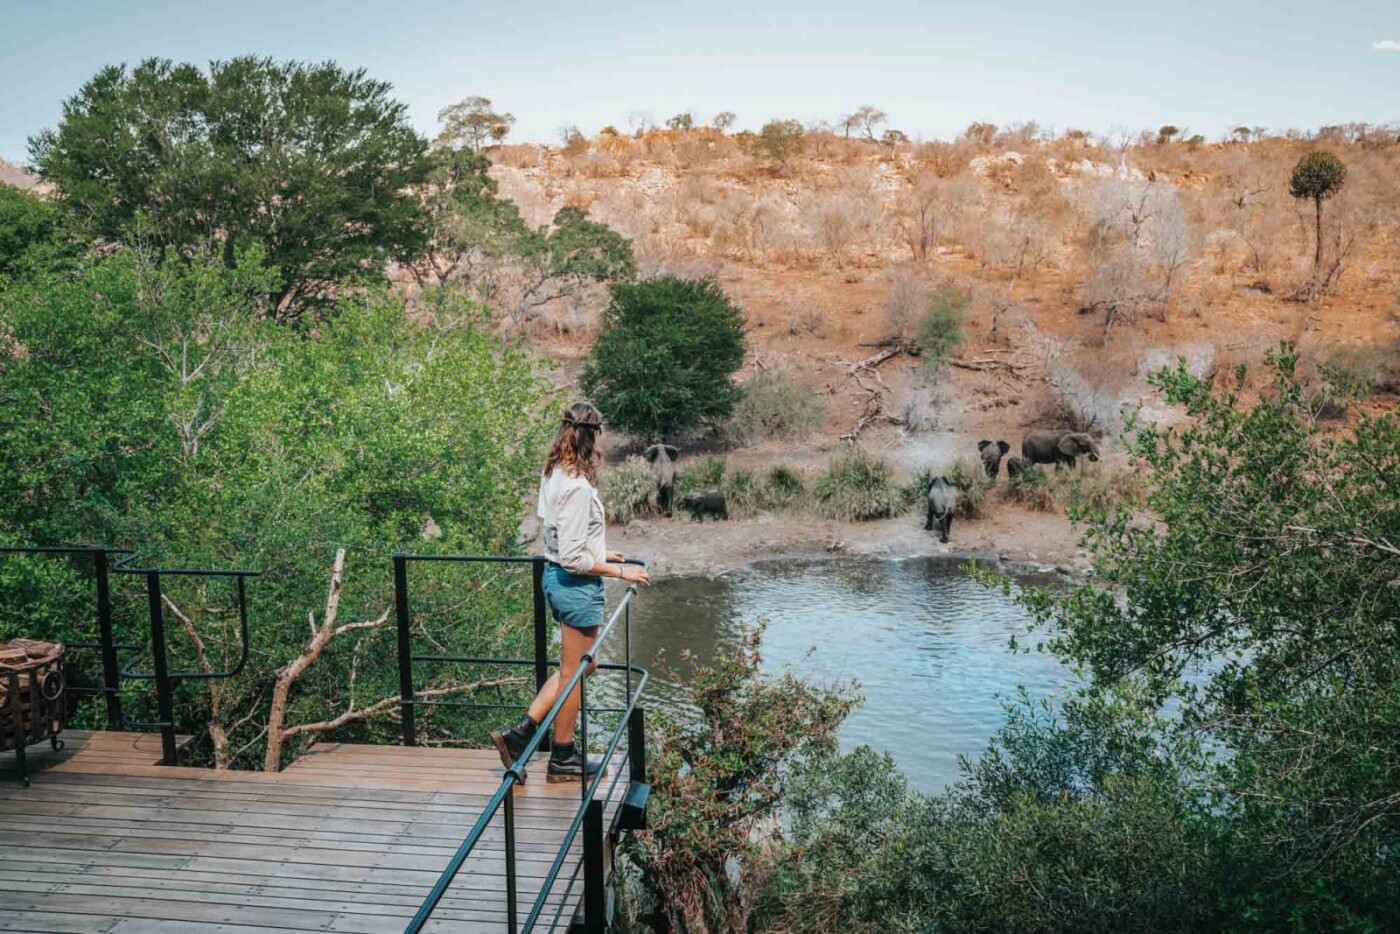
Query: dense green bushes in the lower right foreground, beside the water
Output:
[[633, 347, 1400, 933]]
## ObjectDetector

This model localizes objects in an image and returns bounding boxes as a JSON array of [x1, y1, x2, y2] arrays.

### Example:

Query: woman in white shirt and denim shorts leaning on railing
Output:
[[491, 402, 650, 781]]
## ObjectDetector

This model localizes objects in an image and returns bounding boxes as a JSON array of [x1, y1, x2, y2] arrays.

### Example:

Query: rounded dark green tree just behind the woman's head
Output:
[[582, 276, 745, 440]]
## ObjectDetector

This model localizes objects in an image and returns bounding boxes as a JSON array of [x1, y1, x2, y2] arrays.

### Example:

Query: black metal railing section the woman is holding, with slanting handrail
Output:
[[393, 555, 647, 934]]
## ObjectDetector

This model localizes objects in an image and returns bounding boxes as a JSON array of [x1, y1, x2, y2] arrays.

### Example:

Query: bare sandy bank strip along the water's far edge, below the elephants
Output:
[[608, 504, 1089, 577]]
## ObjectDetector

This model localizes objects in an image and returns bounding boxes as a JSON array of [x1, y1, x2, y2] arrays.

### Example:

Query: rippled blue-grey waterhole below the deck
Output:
[[601, 559, 1074, 791]]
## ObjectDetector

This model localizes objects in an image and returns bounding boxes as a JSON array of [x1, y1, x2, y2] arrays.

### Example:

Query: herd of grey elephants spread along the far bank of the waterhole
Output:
[[643, 428, 1099, 542]]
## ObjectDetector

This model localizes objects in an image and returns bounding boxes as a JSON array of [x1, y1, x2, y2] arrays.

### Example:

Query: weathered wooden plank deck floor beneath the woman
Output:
[[0, 732, 627, 934]]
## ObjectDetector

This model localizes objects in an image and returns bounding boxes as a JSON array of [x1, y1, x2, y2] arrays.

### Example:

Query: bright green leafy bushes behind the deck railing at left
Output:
[[0, 249, 549, 763]]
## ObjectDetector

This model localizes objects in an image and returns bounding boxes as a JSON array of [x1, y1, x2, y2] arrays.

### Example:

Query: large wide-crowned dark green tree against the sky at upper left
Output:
[[29, 57, 426, 319]]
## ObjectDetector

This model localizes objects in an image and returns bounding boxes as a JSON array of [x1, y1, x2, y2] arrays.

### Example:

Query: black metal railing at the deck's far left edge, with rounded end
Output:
[[0, 545, 258, 765]]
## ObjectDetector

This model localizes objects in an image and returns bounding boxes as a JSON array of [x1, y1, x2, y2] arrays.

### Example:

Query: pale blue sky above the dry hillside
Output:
[[0, 0, 1400, 162]]
